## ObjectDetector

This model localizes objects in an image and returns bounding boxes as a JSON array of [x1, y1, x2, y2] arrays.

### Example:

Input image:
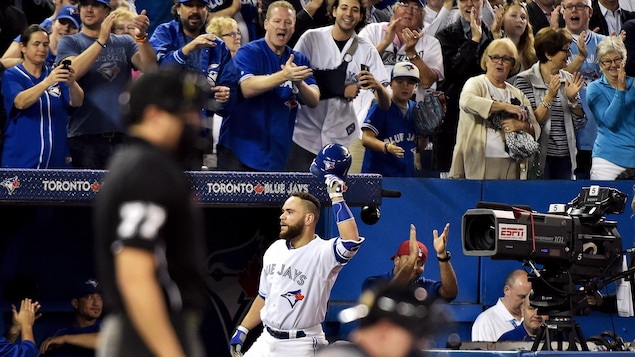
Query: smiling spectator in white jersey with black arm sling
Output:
[[286, 0, 391, 171]]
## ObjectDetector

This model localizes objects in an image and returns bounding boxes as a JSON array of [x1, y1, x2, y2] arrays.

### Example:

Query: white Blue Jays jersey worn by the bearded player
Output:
[[258, 235, 364, 330]]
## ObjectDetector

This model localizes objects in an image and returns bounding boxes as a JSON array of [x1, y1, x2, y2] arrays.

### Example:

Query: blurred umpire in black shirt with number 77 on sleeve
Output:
[[94, 71, 209, 357]]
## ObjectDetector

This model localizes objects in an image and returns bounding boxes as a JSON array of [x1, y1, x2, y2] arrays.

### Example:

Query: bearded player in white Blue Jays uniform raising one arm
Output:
[[230, 182, 364, 357]]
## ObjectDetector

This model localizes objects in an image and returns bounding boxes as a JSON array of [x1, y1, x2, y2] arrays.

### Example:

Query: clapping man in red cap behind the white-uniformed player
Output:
[[362, 223, 459, 301]]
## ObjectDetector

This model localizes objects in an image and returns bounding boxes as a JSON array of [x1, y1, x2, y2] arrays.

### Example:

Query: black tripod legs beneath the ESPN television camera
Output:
[[531, 316, 589, 352]]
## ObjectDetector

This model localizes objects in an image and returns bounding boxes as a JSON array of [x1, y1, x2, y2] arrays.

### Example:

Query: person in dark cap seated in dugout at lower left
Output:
[[40, 279, 104, 357]]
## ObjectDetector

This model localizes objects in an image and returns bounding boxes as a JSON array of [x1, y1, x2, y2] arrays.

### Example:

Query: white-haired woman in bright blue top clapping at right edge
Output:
[[586, 37, 635, 180]]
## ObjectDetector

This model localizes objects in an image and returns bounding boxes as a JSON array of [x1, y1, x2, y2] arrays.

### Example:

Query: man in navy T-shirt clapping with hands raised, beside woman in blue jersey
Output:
[[55, 0, 157, 169]]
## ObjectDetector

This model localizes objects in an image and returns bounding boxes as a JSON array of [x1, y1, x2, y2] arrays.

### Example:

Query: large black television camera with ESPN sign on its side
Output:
[[461, 185, 628, 349]]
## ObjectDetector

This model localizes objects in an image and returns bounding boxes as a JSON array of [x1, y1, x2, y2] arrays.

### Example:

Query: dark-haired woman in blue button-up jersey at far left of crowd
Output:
[[2, 25, 84, 169]]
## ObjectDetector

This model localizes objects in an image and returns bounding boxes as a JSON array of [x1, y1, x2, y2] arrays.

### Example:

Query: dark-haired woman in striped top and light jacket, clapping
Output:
[[515, 27, 586, 180]]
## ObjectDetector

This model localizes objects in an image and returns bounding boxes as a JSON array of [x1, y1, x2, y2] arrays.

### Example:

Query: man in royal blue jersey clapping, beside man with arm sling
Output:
[[216, 1, 320, 171]]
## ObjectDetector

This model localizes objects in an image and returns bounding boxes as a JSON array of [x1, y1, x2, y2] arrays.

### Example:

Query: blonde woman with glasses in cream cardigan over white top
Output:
[[450, 38, 540, 180]]
